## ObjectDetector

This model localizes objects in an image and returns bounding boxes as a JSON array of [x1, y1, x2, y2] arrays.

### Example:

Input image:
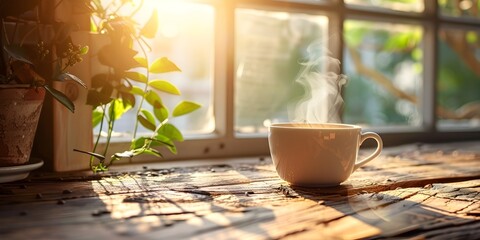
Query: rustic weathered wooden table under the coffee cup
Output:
[[0, 142, 480, 239]]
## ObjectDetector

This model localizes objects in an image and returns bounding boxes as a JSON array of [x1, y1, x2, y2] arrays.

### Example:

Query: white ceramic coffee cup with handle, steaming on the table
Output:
[[268, 123, 383, 186]]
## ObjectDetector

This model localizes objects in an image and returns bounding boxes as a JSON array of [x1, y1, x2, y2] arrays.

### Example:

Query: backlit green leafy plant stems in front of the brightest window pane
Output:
[[75, 0, 200, 172]]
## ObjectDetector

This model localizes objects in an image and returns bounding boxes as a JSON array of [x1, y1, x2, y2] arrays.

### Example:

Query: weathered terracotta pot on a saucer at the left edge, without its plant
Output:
[[0, 85, 45, 166]]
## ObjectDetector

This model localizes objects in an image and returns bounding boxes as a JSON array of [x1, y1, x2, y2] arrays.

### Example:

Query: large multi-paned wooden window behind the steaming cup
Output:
[[55, 0, 480, 170]]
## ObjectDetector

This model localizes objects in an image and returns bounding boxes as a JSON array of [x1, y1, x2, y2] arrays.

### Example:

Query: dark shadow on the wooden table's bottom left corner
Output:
[[0, 174, 125, 239]]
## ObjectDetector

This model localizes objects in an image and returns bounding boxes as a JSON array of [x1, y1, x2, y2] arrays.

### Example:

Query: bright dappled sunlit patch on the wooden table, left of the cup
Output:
[[89, 169, 274, 239]]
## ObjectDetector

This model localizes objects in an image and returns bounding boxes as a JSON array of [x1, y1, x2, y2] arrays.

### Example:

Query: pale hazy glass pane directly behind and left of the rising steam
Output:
[[235, 9, 328, 133]]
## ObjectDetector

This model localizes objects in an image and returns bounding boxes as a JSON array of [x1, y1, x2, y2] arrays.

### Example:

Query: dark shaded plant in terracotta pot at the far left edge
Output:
[[0, 0, 88, 166]]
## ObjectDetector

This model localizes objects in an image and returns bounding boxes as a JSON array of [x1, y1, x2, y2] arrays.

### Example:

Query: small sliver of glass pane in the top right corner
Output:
[[438, 0, 480, 19]]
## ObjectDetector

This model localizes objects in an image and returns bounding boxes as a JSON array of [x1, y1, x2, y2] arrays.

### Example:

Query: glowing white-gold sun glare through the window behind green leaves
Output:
[[92, 0, 216, 135]]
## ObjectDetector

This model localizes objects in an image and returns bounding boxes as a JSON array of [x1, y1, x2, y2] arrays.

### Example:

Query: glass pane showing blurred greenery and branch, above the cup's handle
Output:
[[343, 20, 423, 126]]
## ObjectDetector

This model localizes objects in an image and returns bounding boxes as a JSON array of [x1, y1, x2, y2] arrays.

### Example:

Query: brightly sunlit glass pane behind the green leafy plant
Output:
[[94, 0, 215, 141]]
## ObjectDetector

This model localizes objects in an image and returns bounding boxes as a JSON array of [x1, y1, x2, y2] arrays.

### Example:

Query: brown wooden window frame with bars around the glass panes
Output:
[[53, 0, 480, 171]]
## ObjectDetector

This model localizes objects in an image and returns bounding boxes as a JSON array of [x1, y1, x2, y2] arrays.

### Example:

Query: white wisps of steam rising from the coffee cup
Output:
[[289, 43, 347, 123]]
